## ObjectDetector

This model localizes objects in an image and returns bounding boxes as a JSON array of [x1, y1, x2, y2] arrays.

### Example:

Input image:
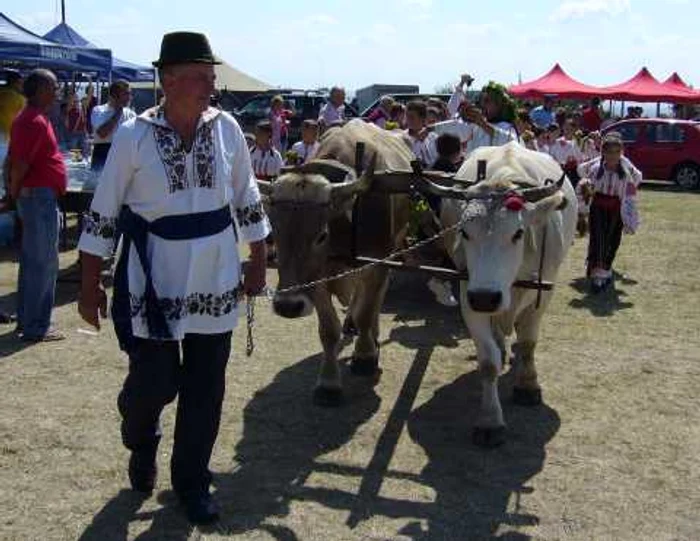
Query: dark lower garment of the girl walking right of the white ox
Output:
[[588, 194, 622, 275]]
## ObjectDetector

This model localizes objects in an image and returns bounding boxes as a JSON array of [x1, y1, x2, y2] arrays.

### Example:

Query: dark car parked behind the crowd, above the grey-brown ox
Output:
[[233, 91, 358, 143]]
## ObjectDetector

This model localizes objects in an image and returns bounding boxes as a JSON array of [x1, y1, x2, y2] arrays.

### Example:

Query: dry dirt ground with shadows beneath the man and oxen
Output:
[[0, 185, 700, 541]]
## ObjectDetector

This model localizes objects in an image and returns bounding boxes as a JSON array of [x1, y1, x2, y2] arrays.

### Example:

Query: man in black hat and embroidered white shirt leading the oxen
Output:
[[79, 32, 270, 524]]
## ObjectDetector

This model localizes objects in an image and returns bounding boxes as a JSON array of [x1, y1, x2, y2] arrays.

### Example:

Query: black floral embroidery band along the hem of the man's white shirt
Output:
[[130, 284, 243, 321]]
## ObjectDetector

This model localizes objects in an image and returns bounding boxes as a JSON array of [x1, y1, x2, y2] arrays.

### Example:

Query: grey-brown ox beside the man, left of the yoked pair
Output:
[[258, 120, 415, 406]]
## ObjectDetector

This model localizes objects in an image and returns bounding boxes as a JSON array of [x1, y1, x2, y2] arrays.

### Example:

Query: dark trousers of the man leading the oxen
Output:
[[118, 332, 231, 495]]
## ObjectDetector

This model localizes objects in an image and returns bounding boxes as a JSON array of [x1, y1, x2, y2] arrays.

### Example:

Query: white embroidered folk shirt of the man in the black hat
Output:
[[78, 107, 270, 340]]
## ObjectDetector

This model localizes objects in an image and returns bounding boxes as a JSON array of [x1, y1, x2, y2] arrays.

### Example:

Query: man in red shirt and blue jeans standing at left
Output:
[[9, 69, 66, 342]]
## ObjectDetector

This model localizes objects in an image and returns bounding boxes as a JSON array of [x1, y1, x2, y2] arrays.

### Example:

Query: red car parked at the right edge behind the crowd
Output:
[[603, 118, 700, 190]]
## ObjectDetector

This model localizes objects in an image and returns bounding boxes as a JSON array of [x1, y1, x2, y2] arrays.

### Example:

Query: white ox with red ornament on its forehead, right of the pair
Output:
[[441, 143, 577, 446]]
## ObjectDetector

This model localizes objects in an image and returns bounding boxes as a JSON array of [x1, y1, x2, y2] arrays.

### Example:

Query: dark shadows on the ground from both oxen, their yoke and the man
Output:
[[80, 274, 559, 541]]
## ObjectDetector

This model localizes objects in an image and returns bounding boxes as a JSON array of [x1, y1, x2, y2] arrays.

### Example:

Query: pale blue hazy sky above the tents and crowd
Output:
[[6, 0, 700, 92]]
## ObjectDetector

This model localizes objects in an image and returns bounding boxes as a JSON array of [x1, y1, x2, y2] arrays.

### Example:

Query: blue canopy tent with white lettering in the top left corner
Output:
[[0, 13, 112, 77]]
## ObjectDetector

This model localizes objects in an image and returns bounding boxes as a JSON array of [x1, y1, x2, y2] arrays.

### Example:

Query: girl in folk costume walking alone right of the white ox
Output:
[[577, 133, 642, 292]]
